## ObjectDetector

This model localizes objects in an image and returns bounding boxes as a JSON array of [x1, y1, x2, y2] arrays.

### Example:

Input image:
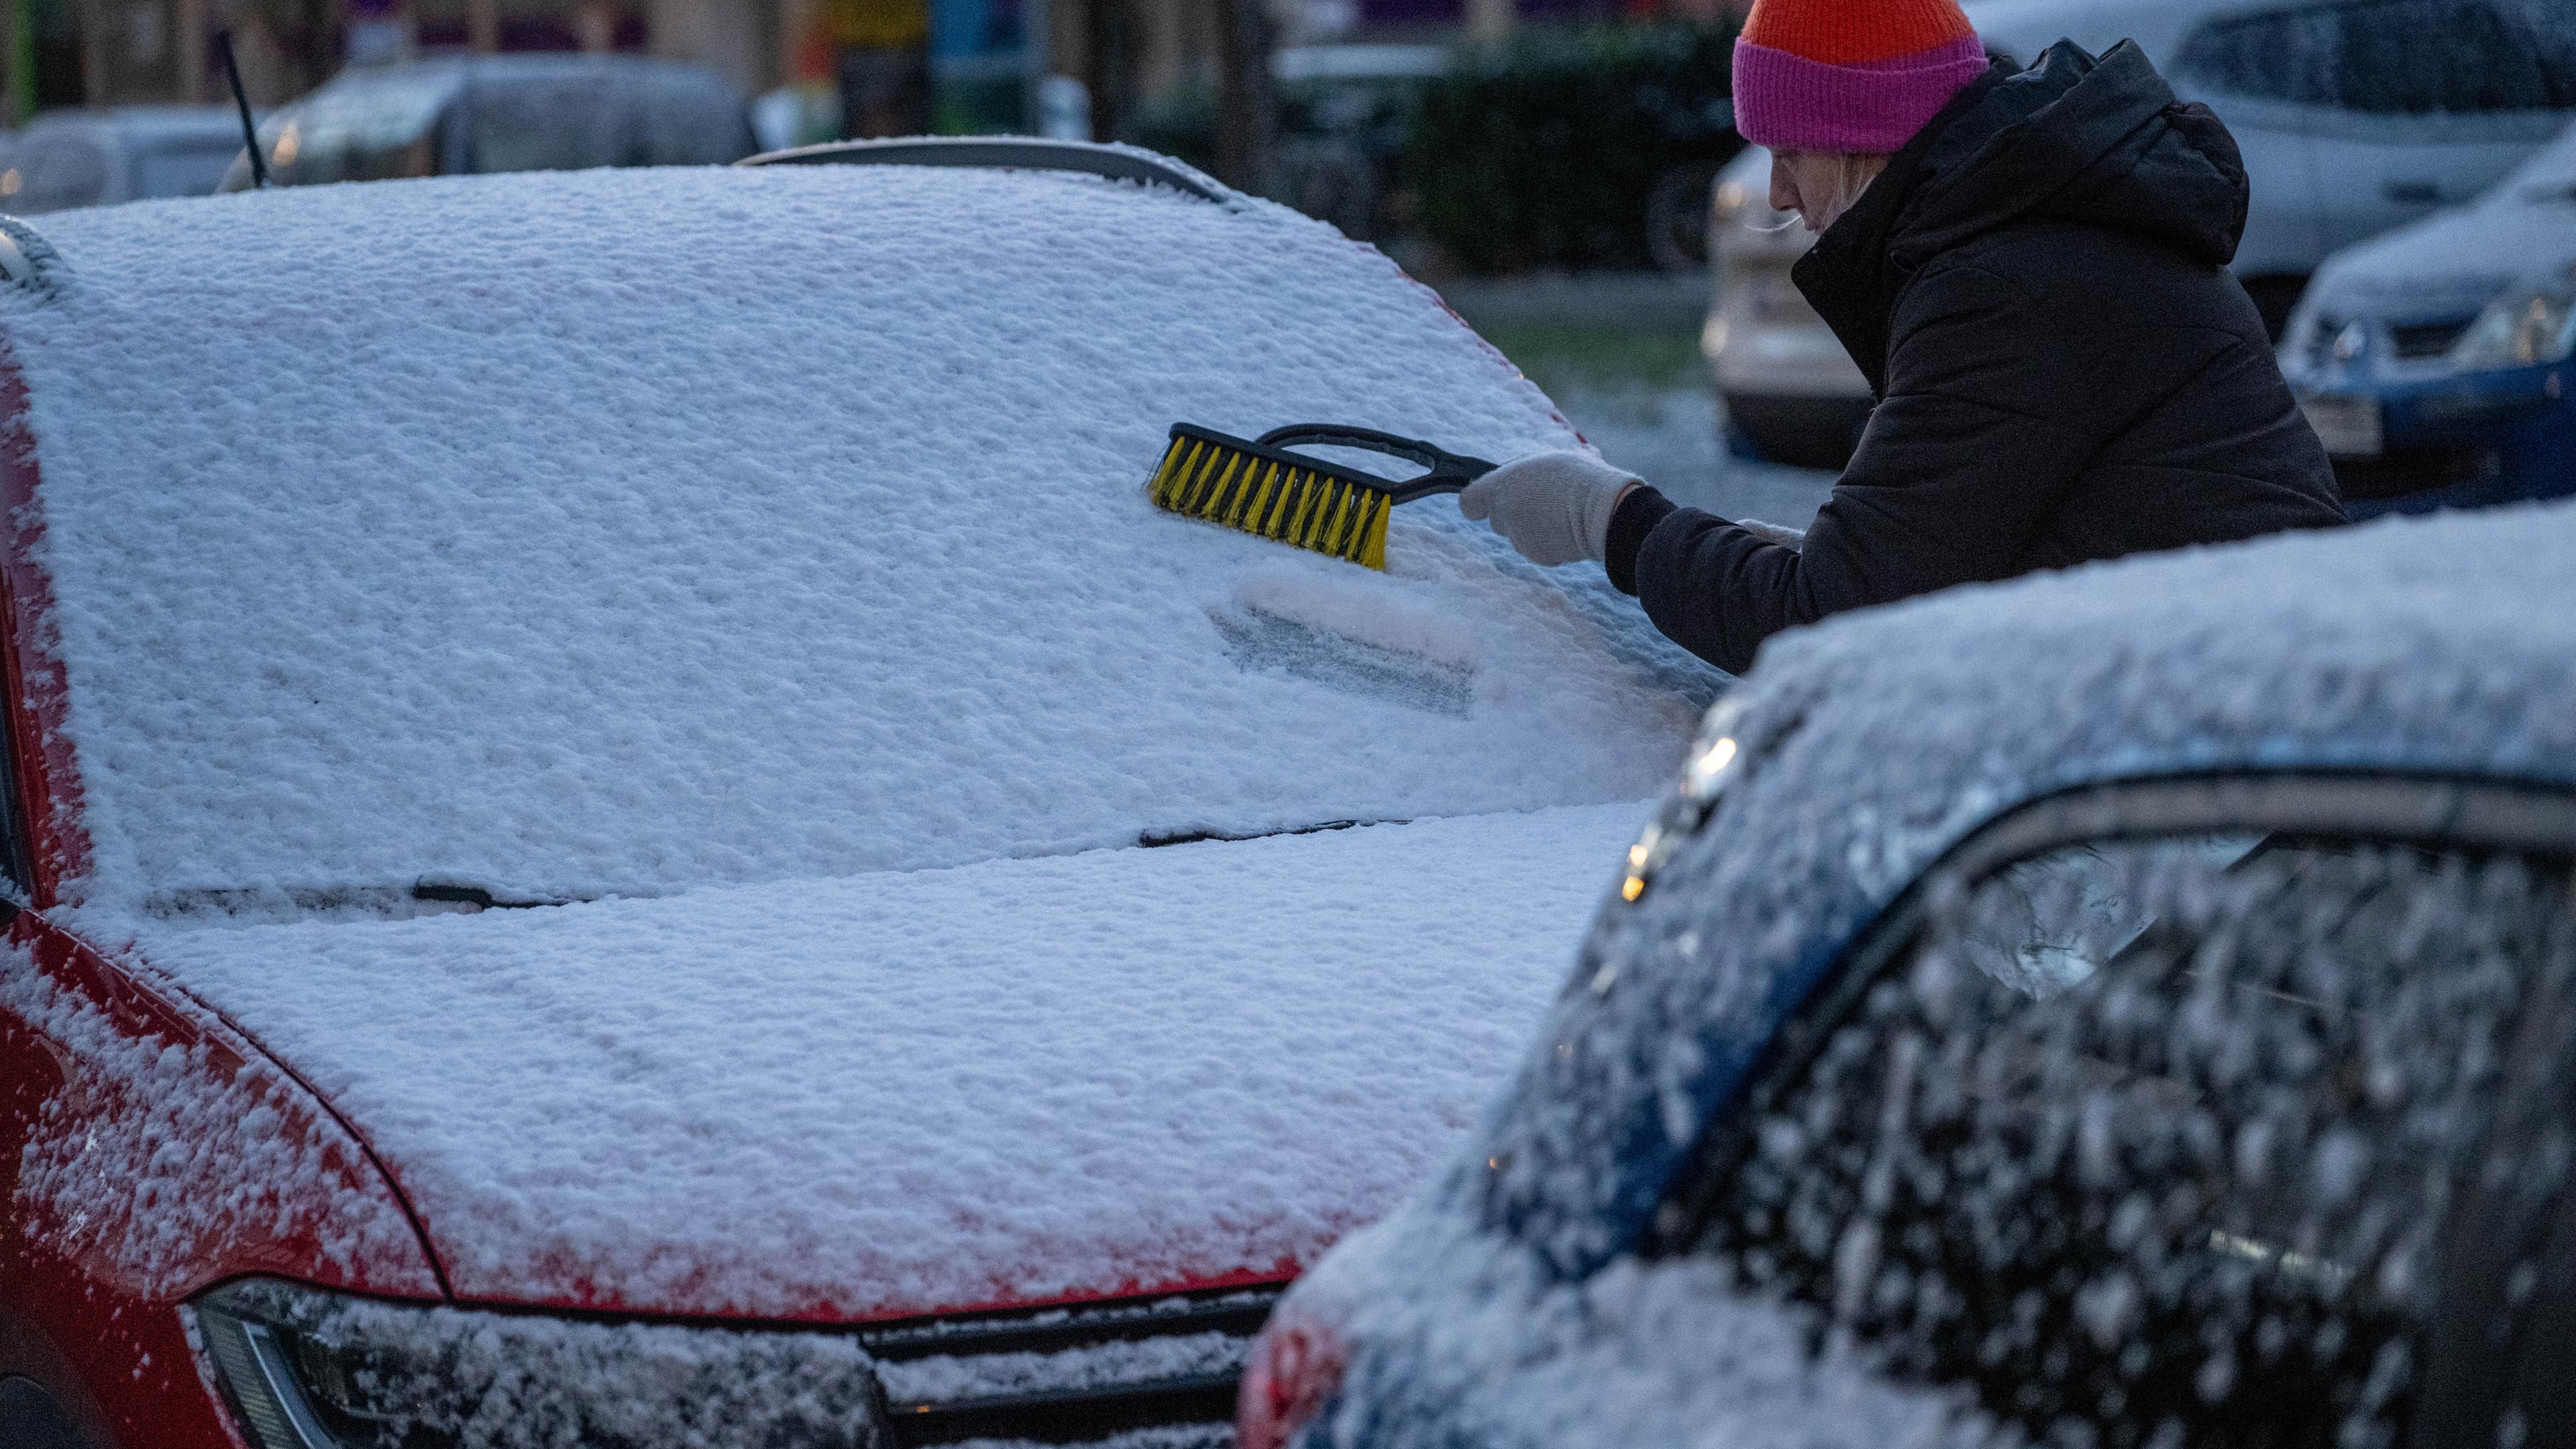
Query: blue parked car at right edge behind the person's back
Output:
[[2282, 126, 2576, 513]]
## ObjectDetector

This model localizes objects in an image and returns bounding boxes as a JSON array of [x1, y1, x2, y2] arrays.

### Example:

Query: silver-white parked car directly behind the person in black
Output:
[[1703, 0, 2576, 467]]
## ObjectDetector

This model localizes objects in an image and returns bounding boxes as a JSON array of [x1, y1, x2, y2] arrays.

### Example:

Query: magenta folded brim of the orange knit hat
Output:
[[1736, 36, 1986, 155]]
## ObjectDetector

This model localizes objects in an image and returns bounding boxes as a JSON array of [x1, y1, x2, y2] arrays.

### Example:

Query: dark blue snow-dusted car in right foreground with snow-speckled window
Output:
[[1244, 505, 2576, 1449]]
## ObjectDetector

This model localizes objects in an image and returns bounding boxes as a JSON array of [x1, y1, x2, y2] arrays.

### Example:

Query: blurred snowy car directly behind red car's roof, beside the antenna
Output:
[[221, 54, 760, 191]]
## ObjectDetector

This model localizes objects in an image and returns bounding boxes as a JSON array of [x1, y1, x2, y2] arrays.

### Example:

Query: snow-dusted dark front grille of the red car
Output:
[[863, 1287, 1280, 1449]]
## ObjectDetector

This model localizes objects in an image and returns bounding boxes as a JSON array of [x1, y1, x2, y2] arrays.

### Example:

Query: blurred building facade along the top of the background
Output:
[[0, 0, 1741, 131]]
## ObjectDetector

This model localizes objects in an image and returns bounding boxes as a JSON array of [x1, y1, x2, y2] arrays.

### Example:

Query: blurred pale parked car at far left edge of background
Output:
[[0, 106, 242, 217]]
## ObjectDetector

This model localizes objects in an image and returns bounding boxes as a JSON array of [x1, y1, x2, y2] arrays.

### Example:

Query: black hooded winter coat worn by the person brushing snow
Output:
[[1607, 44, 2344, 673]]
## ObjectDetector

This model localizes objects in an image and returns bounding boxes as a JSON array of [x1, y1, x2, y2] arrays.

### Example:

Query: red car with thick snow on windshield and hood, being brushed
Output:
[[0, 141, 1723, 1449]]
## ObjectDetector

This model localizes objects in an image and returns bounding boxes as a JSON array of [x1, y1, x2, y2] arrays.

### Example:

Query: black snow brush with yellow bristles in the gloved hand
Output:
[[1149, 423, 1494, 570]]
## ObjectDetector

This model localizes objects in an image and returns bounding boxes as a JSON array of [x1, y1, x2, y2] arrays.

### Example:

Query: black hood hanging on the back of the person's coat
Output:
[[1795, 41, 2249, 389]]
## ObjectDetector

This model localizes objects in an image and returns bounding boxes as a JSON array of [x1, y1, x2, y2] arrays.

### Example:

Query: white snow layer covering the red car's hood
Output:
[[108, 804, 1635, 1318]]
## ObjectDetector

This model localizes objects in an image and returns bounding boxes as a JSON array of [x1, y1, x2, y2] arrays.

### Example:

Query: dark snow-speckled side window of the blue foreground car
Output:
[[1695, 838, 2576, 1449]]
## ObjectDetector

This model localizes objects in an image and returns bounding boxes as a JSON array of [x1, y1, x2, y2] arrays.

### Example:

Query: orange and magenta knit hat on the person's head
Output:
[[1736, 0, 1986, 155]]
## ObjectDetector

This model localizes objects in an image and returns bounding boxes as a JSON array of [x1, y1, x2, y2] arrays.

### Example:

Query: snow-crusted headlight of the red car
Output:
[[191, 1279, 889, 1449]]
